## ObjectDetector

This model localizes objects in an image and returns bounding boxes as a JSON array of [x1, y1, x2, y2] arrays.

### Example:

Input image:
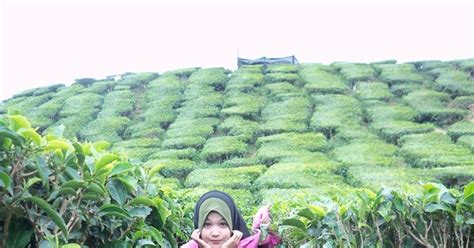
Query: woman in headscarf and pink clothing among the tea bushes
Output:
[[182, 190, 281, 248]]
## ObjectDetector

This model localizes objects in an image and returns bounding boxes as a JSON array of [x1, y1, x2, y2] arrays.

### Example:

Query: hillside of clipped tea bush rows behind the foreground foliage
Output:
[[0, 59, 474, 209]]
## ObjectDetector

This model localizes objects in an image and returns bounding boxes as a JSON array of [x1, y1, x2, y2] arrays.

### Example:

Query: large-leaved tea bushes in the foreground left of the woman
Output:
[[0, 115, 192, 247]]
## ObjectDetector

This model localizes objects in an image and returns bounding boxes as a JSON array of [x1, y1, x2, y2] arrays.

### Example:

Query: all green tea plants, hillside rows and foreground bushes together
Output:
[[0, 60, 474, 247]]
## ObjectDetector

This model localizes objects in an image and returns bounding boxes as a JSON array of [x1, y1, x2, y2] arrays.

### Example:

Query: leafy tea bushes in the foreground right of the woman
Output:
[[279, 182, 474, 247]]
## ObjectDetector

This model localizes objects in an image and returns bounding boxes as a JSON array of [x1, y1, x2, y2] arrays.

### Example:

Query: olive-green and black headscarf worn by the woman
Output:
[[194, 190, 250, 239]]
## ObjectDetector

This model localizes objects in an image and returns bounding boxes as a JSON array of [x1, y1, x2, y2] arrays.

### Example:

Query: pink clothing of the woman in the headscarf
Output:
[[181, 205, 281, 248]]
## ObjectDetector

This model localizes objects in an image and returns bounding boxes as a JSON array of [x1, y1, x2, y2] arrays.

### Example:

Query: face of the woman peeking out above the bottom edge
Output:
[[201, 212, 230, 248]]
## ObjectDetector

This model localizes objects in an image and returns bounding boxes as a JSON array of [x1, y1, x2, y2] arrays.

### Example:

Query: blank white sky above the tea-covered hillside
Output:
[[0, 0, 474, 100]]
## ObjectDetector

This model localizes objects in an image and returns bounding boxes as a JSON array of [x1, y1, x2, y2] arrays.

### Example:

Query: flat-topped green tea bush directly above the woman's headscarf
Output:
[[184, 165, 266, 189]]
